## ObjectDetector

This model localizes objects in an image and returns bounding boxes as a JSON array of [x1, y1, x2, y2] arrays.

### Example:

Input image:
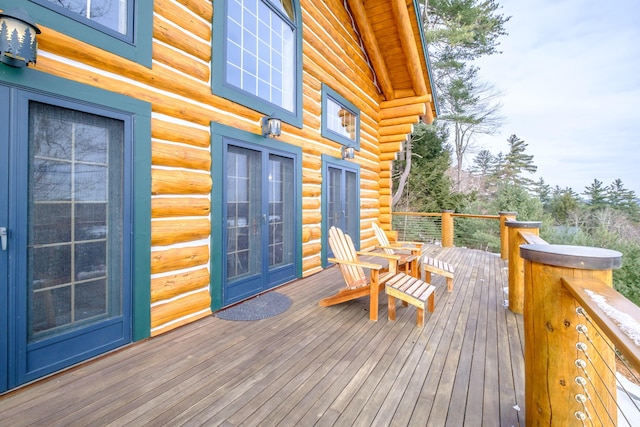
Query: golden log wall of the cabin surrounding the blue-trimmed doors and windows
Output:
[[7, 0, 431, 335]]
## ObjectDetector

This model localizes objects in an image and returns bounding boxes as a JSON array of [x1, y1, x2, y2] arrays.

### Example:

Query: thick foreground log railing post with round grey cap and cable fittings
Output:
[[520, 244, 622, 426]]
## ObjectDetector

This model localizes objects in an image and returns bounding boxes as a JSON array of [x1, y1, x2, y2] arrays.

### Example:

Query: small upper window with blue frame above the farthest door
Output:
[[322, 84, 360, 150]]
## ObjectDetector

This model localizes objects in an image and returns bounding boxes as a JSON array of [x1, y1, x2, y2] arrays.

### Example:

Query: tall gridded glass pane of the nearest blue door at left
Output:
[[27, 102, 124, 341]]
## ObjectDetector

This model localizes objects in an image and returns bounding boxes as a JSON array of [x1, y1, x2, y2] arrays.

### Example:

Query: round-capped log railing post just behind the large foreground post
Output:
[[505, 221, 542, 314]]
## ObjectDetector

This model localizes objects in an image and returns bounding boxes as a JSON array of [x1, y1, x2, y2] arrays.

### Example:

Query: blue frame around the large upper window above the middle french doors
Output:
[[211, 0, 302, 128]]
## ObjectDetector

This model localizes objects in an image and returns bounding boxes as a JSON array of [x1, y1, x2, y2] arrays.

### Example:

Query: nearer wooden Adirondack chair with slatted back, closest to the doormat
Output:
[[319, 227, 398, 320]]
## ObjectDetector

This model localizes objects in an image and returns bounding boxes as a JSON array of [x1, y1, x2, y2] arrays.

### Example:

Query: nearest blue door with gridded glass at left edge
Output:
[[0, 86, 131, 391]]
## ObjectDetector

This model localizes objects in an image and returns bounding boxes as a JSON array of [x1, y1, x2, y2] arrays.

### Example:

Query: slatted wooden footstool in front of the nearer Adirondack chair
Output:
[[385, 273, 436, 327]]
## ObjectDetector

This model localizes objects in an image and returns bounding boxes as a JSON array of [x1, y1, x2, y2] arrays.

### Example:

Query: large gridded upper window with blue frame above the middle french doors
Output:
[[212, 0, 302, 125]]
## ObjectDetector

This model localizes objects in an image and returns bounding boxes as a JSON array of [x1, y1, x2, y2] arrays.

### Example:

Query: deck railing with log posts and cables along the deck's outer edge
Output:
[[393, 211, 640, 426]]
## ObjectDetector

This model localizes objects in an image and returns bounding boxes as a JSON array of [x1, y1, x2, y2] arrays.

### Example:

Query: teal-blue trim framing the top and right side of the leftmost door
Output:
[[0, 64, 151, 341]]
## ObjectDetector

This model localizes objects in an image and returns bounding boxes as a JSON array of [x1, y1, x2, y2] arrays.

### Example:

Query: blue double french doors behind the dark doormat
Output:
[[223, 142, 297, 305]]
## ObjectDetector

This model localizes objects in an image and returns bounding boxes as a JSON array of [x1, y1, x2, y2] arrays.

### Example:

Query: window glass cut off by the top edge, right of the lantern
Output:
[[38, 0, 134, 35]]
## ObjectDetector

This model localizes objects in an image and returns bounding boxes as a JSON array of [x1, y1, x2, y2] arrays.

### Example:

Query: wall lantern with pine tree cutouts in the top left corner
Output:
[[0, 8, 40, 67]]
